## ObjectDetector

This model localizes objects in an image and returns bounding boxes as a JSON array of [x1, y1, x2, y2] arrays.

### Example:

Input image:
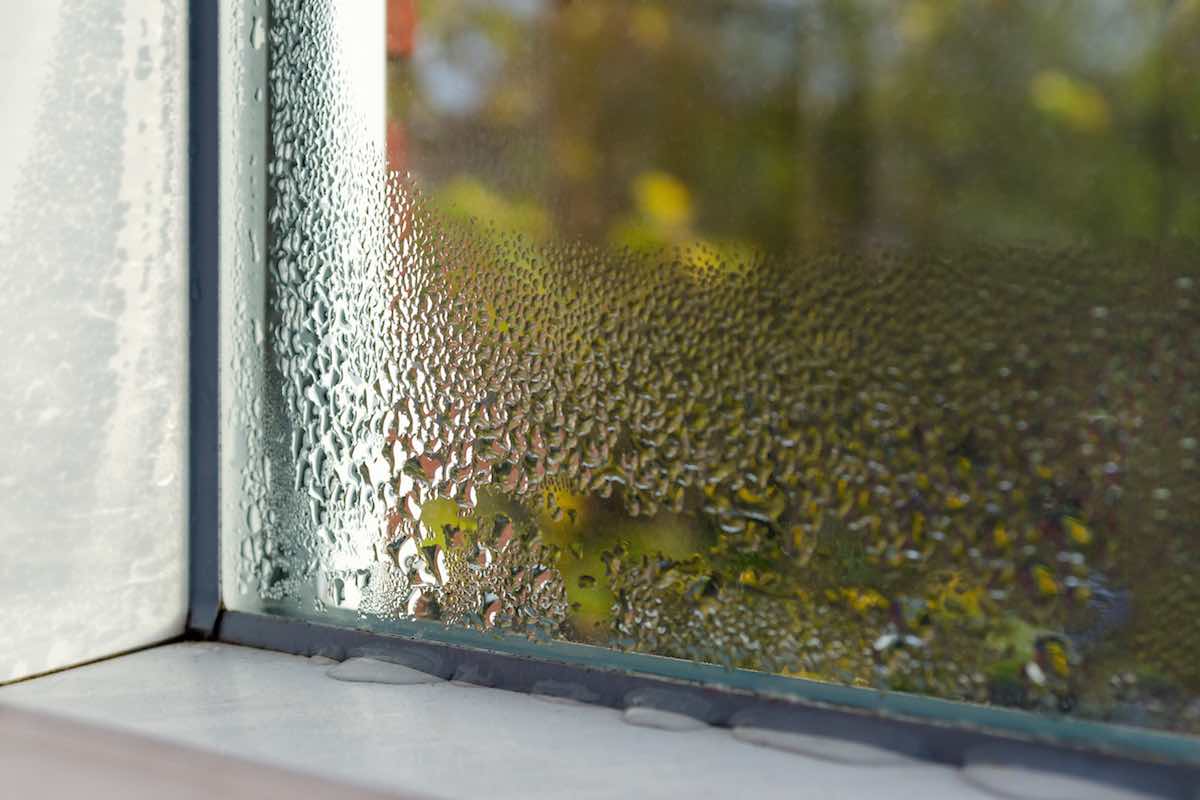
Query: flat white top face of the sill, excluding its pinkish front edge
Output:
[[0, 644, 991, 800]]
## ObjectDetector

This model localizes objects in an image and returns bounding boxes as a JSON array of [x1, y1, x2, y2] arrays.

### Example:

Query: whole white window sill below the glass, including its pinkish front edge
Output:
[[0, 643, 1161, 800]]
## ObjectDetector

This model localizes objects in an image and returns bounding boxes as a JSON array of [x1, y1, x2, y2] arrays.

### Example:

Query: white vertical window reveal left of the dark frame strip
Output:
[[0, 0, 187, 681]]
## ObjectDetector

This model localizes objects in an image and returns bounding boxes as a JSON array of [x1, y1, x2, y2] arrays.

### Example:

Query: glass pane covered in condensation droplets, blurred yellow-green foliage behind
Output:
[[227, 0, 1200, 732]]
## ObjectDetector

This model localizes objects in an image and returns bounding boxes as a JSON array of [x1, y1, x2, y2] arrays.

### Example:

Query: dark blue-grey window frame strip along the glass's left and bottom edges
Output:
[[187, 0, 1200, 796]]
